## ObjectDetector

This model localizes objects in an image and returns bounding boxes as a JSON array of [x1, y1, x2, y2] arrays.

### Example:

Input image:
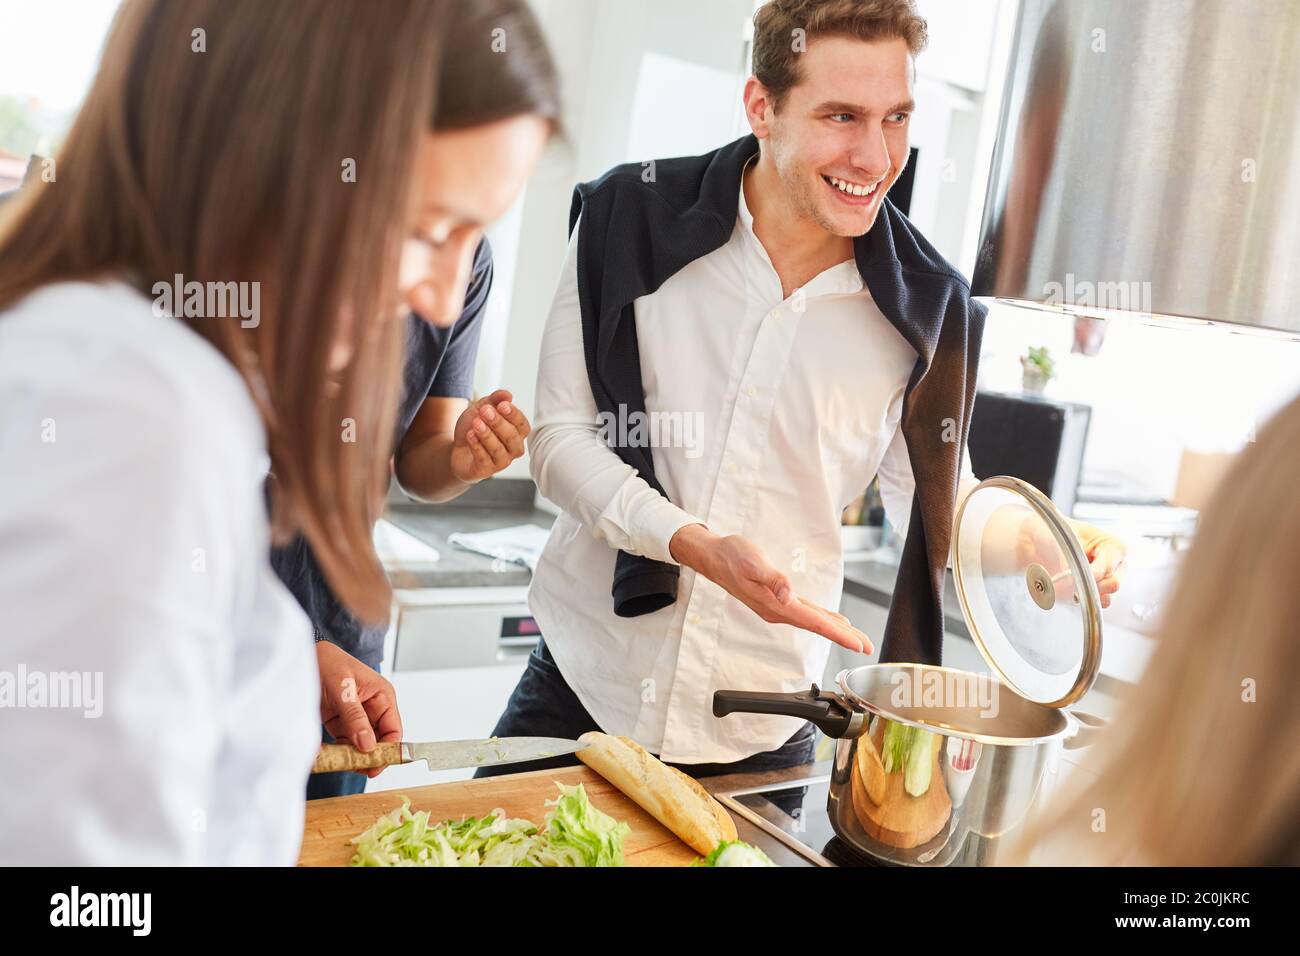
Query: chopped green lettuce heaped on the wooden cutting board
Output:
[[352, 784, 629, 866]]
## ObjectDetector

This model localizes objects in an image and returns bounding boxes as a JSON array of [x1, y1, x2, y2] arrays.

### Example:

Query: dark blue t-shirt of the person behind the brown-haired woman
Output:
[[270, 239, 491, 670]]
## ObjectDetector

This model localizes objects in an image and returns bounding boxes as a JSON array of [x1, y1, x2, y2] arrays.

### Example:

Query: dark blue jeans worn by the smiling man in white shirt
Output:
[[475, 640, 815, 777]]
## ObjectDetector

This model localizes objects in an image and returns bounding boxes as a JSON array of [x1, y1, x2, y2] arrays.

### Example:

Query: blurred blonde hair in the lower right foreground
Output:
[[1009, 398, 1300, 866]]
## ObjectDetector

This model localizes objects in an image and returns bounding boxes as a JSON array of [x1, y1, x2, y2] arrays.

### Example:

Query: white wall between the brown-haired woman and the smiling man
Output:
[[477, 0, 750, 476]]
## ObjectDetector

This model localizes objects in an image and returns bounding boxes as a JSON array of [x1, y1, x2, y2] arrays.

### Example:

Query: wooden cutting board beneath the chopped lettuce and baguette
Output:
[[298, 767, 699, 866]]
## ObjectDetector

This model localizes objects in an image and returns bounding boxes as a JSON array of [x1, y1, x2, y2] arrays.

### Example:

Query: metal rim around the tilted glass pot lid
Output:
[[949, 475, 1101, 710]]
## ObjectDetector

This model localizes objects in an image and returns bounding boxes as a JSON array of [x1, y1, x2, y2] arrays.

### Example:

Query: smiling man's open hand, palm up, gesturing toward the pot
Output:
[[668, 524, 871, 654]]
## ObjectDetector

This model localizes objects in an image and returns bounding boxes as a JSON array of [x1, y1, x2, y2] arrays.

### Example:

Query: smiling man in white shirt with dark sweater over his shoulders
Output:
[[480, 0, 1123, 775]]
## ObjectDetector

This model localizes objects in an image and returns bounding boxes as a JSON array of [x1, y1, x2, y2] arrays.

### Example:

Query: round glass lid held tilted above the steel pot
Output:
[[952, 476, 1101, 708]]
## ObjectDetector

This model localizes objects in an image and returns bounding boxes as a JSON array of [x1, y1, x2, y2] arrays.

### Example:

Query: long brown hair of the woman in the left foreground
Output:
[[0, 0, 558, 622]]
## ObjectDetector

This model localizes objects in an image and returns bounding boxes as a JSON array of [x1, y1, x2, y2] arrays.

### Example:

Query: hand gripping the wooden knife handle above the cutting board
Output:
[[316, 641, 402, 777]]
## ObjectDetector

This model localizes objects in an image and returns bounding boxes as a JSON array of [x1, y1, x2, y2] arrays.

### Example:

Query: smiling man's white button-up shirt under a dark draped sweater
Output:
[[529, 162, 972, 763]]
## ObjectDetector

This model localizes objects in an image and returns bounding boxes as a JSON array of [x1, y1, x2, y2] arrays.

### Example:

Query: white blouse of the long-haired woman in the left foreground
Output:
[[0, 282, 320, 865]]
